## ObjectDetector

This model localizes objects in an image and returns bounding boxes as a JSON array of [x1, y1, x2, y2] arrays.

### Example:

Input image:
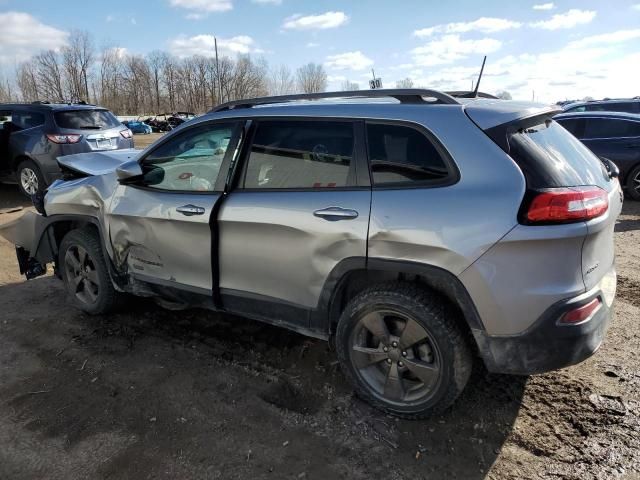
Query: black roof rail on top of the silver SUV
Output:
[[209, 88, 458, 113]]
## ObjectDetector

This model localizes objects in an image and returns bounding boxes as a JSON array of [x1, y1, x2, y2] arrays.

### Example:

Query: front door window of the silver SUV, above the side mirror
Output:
[[142, 123, 235, 192]]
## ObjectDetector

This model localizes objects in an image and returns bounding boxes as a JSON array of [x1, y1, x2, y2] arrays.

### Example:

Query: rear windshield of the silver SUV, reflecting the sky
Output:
[[509, 120, 609, 189]]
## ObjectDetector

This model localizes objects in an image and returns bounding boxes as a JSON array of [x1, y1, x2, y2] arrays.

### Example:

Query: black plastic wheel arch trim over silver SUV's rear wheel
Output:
[[311, 258, 485, 346]]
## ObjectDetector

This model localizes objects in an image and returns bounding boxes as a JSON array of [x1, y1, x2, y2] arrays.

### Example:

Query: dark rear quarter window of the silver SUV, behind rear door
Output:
[[367, 123, 450, 185]]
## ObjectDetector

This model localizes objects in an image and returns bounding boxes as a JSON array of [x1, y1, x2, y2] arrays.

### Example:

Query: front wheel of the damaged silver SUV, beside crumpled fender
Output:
[[58, 228, 123, 315]]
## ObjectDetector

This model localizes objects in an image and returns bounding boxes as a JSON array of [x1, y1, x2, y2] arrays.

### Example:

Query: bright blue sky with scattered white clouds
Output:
[[0, 0, 640, 102]]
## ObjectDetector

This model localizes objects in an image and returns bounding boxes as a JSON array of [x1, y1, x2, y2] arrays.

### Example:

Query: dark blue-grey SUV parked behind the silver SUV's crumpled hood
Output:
[[0, 102, 133, 196]]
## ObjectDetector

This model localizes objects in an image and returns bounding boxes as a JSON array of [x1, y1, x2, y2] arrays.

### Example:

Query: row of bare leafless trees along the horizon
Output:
[[5, 31, 327, 115]]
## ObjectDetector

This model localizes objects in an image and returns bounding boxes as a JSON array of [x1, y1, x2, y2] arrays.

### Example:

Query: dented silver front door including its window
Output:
[[107, 122, 238, 295]]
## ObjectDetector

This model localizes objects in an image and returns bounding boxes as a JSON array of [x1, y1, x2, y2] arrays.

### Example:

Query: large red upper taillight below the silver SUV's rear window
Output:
[[527, 187, 609, 223]]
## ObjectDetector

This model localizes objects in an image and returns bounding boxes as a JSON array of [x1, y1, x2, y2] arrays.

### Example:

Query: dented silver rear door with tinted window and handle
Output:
[[218, 119, 371, 316]]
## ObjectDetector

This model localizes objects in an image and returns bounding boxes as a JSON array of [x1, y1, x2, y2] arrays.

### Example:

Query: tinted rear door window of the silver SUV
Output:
[[243, 120, 354, 188]]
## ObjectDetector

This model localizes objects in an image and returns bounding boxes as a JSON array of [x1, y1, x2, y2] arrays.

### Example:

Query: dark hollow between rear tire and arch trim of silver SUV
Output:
[[328, 267, 484, 350]]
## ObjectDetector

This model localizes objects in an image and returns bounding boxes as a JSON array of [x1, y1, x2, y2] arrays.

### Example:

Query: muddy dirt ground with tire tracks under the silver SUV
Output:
[[0, 181, 640, 480]]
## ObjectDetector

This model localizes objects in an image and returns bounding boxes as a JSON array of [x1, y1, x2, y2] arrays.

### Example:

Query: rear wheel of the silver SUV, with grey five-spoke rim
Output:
[[336, 283, 473, 419]]
